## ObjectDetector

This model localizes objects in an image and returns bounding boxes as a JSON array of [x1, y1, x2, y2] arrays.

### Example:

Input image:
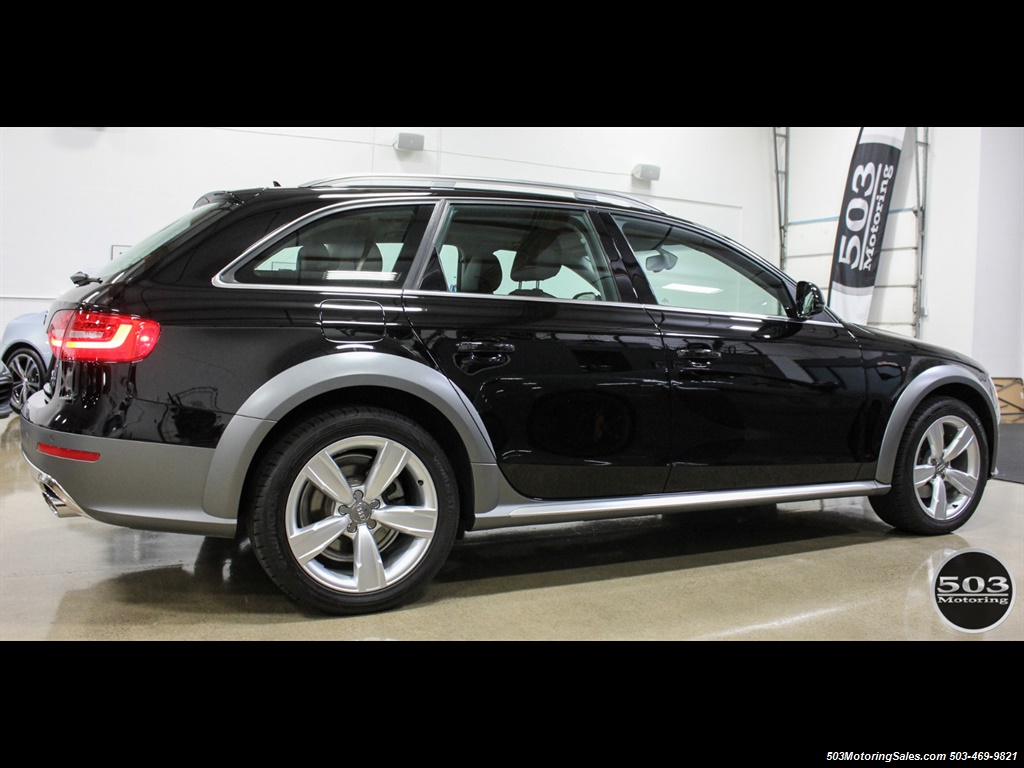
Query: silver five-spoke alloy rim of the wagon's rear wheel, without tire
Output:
[[285, 435, 438, 594]]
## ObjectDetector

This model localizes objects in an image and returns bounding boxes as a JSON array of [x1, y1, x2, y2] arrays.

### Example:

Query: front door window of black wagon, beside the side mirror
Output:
[[613, 215, 791, 316]]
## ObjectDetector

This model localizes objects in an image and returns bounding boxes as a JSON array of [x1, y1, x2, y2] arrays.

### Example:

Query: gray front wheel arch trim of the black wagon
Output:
[[874, 365, 999, 484]]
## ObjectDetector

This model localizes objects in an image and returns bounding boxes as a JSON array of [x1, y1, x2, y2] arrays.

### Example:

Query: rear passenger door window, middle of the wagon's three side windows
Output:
[[437, 204, 618, 301]]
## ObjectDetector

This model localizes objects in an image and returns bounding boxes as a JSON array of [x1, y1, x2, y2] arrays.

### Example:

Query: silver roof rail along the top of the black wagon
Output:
[[300, 173, 663, 213]]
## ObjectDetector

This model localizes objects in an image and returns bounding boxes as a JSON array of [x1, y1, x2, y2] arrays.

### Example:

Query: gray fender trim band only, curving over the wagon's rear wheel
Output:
[[203, 351, 495, 518]]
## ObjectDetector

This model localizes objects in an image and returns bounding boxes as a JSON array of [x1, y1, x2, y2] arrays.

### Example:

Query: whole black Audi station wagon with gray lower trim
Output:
[[22, 177, 998, 613]]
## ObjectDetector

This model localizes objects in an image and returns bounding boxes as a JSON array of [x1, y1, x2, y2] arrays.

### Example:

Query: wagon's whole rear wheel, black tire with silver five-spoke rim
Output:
[[251, 408, 459, 614]]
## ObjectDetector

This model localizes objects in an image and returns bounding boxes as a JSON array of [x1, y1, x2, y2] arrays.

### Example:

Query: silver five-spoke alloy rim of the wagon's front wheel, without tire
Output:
[[913, 416, 981, 520]]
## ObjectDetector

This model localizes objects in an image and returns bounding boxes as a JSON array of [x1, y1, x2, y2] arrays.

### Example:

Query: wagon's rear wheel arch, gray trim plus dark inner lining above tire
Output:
[[203, 351, 495, 527]]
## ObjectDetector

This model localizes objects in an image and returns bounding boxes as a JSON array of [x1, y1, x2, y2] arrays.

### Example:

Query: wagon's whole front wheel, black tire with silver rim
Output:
[[870, 397, 989, 536]]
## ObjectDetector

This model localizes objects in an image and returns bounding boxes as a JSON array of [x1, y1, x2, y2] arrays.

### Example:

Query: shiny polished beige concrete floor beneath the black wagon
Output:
[[0, 417, 1024, 642]]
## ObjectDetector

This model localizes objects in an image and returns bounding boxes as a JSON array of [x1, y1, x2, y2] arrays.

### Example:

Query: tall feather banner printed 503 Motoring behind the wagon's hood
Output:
[[828, 128, 906, 324]]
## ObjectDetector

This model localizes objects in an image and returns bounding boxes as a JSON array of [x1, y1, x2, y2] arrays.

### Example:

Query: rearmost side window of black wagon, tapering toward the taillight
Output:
[[233, 206, 432, 288]]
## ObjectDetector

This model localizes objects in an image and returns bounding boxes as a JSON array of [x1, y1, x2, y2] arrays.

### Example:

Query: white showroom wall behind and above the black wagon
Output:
[[0, 126, 1024, 376]]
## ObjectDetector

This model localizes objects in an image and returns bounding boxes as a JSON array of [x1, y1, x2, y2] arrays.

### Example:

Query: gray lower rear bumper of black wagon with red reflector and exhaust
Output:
[[20, 411, 236, 538]]
